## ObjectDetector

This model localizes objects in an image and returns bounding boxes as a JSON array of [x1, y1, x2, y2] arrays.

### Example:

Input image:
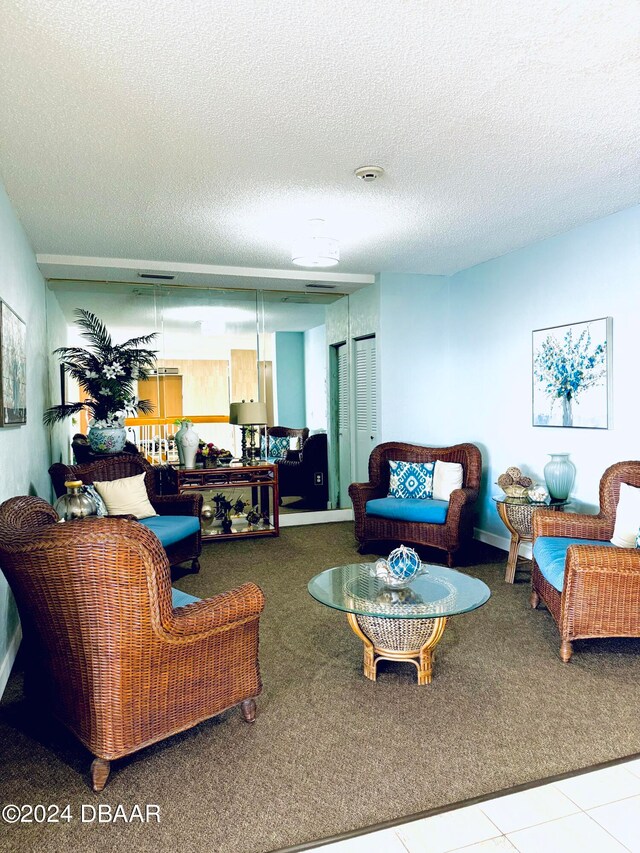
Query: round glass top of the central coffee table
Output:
[[307, 563, 491, 619]]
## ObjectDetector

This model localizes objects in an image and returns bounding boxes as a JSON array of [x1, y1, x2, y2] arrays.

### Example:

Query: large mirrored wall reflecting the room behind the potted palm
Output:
[[49, 281, 348, 512]]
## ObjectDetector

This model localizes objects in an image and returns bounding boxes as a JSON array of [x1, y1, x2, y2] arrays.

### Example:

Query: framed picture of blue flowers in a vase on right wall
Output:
[[532, 317, 613, 429]]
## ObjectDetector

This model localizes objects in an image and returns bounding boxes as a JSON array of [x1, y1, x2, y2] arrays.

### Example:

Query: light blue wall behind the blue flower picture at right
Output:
[[380, 207, 640, 541]]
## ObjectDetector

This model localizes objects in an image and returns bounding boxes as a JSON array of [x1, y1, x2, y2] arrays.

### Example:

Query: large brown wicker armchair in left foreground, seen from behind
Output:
[[0, 497, 264, 791]]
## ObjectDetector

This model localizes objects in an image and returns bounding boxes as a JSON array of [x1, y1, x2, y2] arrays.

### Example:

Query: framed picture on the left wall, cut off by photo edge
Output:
[[0, 299, 27, 426]]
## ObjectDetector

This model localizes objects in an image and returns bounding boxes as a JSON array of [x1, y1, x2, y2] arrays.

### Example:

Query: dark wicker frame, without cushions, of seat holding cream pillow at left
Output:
[[49, 453, 202, 572]]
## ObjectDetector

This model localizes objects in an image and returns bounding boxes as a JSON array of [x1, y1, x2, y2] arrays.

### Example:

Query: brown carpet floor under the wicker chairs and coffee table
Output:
[[0, 523, 640, 853]]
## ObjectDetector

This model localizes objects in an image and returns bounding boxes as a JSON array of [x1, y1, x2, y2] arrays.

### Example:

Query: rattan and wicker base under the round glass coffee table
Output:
[[347, 613, 447, 684]]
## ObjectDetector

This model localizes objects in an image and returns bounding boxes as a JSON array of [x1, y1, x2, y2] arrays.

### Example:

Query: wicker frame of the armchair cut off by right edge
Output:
[[531, 461, 640, 663]]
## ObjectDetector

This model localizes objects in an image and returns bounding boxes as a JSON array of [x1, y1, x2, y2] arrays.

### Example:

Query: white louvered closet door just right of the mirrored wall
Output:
[[354, 338, 378, 483]]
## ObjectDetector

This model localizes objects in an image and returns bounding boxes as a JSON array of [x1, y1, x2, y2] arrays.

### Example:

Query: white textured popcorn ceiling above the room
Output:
[[0, 0, 640, 274]]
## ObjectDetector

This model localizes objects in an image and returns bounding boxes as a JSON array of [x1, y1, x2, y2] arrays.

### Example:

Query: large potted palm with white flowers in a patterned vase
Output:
[[43, 308, 157, 453]]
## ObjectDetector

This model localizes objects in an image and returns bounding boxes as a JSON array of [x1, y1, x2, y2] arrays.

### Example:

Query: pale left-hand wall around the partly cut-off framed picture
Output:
[[0, 184, 51, 695]]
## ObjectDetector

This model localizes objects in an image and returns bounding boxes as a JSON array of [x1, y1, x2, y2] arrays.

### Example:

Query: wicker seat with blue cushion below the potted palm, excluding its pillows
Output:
[[49, 453, 202, 572]]
